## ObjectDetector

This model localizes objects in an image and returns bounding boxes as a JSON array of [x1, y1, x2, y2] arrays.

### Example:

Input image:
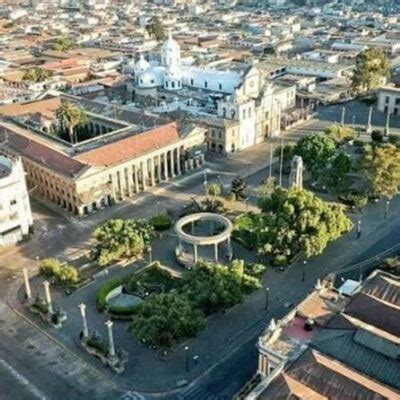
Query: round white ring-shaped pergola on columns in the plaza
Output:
[[175, 212, 233, 267]]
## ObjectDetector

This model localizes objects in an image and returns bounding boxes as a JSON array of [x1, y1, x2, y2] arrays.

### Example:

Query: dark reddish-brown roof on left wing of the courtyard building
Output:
[[0, 127, 87, 178]]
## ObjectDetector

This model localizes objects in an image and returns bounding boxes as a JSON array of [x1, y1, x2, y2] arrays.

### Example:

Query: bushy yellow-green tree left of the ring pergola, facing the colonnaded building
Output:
[[92, 219, 154, 267]]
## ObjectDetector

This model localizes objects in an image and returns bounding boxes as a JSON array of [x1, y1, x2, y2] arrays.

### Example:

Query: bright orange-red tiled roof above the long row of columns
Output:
[[76, 122, 179, 167]]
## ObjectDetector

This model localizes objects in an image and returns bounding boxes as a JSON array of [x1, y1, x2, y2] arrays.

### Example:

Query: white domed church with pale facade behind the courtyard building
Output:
[[125, 34, 296, 155]]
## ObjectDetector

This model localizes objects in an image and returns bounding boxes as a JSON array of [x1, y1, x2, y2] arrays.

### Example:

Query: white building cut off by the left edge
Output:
[[0, 152, 33, 247]]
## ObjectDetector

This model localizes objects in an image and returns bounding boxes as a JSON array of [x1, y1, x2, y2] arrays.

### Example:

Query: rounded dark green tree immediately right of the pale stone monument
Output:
[[294, 133, 336, 179]]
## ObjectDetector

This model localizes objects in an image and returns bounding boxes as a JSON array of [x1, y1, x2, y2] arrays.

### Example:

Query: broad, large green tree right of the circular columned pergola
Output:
[[244, 187, 352, 260]]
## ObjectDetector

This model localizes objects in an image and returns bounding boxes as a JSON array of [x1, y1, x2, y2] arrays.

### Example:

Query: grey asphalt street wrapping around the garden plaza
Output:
[[0, 105, 400, 400]]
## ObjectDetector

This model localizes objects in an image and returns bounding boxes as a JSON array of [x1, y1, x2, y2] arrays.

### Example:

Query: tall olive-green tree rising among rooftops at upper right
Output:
[[351, 48, 390, 93]]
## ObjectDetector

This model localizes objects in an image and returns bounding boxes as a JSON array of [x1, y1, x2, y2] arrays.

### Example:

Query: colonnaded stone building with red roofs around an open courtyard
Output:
[[0, 93, 204, 216]]
